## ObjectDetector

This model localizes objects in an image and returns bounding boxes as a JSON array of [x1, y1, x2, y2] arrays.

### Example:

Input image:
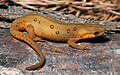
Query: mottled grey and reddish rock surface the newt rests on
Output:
[[0, 7, 120, 75]]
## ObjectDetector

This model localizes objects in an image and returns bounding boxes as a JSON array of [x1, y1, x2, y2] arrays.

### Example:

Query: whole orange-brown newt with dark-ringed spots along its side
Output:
[[10, 12, 105, 70]]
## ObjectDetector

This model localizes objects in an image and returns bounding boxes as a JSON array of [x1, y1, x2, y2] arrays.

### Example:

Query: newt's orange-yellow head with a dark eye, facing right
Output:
[[77, 23, 105, 39]]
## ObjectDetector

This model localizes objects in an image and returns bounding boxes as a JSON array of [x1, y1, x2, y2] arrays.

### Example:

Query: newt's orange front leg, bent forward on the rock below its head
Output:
[[67, 38, 89, 50]]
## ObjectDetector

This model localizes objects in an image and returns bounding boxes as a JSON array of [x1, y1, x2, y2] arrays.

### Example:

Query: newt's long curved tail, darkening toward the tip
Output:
[[10, 21, 45, 71]]
